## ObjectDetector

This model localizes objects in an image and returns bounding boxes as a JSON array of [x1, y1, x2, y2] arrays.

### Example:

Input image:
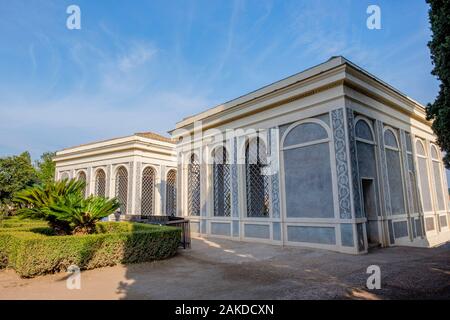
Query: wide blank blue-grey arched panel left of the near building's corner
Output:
[[281, 119, 334, 218]]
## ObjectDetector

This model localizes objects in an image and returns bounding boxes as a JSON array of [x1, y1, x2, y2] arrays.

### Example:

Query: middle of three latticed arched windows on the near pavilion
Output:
[[212, 147, 231, 217]]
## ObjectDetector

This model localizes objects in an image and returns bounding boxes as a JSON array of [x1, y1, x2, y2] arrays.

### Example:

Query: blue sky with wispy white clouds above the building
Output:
[[0, 0, 448, 182]]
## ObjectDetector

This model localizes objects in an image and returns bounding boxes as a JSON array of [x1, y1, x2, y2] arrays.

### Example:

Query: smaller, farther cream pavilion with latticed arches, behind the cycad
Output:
[[55, 133, 177, 215]]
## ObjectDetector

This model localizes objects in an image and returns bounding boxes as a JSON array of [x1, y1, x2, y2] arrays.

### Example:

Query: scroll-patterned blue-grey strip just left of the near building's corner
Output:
[[331, 108, 352, 219]]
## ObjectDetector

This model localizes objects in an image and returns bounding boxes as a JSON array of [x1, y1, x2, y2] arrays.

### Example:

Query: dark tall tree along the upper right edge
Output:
[[427, 0, 450, 169]]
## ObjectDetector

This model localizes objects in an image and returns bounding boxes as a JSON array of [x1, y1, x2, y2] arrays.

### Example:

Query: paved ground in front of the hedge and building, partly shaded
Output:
[[0, 238, 450, 299]]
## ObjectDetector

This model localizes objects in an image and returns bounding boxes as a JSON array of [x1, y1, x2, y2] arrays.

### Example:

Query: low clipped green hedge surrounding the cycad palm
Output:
[[0, 222, 181, 277]]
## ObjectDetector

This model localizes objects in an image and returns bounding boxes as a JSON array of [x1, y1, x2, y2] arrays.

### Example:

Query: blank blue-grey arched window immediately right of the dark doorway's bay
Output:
[[384, 128, 406, 214]]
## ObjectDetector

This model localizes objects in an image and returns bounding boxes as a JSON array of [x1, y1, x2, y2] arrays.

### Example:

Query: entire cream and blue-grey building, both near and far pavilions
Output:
[[56, 57, 450, 254]]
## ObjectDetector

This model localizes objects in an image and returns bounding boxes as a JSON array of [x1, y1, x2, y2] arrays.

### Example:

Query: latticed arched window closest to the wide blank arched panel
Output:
[[245, 137, 269, 218]]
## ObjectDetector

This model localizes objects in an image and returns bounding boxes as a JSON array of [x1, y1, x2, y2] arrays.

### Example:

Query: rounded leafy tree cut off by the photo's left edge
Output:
[[0, 152, 37, 204]]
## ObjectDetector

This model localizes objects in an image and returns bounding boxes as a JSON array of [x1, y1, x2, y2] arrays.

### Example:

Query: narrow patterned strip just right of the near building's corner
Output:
[[347, 108, 363, 218]]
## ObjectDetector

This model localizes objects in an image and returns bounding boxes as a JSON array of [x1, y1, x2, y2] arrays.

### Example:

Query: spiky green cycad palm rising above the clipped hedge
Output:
[[15, 179, 120, 235]]
